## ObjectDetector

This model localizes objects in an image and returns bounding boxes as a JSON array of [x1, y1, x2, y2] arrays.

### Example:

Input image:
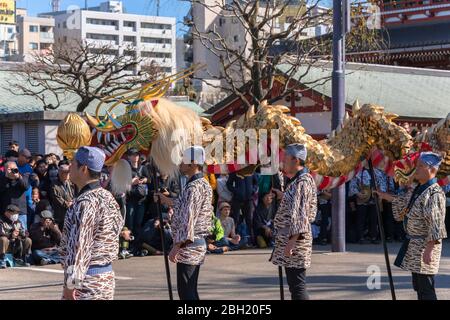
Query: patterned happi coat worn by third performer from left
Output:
[[271, 173, 317, 269]]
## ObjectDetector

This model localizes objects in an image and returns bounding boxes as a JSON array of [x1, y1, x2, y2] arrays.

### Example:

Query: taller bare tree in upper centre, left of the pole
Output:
[[186, 0, 384, 107]]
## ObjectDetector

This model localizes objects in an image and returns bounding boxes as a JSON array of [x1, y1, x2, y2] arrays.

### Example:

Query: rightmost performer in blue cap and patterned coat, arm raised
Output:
[[377, 152, 447, 300]]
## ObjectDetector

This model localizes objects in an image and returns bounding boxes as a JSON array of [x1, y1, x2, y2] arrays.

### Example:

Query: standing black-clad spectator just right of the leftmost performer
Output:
[[125, 148, 149, 235]]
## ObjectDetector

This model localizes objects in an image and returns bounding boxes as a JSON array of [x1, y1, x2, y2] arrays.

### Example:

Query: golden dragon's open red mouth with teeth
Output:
[[91, 124, 137, 165]]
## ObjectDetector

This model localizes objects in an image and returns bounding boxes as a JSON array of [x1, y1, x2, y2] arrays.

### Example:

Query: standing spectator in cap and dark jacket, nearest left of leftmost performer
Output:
[[49, 160, 76, 229]]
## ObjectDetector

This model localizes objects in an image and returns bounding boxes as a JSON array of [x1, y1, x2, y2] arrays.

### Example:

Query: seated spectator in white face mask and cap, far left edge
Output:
[[0, 204, 32, 269]]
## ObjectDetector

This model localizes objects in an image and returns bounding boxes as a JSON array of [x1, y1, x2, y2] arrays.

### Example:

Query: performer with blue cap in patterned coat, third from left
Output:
[[271, 143, 317, 300]]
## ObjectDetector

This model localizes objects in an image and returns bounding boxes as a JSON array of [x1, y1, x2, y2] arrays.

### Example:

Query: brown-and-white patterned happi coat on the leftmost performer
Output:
[[60, 182, 124, 300]]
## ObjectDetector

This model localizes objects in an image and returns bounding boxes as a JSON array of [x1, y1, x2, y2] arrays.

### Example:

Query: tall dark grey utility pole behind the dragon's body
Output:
[[331, 0, 350, 252]]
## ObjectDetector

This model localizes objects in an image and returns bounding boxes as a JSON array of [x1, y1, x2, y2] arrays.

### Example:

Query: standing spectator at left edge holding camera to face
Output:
[[0, 161, 28, 230]]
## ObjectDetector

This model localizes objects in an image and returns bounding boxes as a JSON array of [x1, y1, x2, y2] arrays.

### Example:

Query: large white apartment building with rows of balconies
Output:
[[42, 1, 176, 73]]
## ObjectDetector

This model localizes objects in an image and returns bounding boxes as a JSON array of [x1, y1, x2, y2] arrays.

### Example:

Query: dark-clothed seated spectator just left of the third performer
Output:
[[253, 192, 275, 248]]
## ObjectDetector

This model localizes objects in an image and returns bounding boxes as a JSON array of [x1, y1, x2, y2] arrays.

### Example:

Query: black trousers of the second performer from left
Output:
[[177, 263, 200, 300]]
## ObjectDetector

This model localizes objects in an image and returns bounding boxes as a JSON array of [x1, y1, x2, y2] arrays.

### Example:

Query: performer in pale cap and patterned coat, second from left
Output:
[[155, 146, 214, 300]]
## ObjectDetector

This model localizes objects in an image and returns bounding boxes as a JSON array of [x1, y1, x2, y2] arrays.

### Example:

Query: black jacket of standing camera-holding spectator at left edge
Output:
[[0, 173, 29, 214]]
